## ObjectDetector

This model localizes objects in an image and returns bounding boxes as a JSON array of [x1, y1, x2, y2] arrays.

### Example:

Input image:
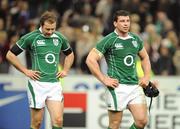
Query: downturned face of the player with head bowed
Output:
[[41, 22, 56, 37]]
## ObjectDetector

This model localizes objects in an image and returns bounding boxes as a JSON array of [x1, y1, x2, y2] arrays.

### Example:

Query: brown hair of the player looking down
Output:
[[40, 11, 57, 25]]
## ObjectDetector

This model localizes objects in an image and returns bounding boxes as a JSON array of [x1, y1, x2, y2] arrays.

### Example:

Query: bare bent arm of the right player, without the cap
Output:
[[86, 48, 118, 88]]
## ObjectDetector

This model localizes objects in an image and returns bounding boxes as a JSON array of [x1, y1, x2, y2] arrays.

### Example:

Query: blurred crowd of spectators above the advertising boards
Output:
[[0, 0, 180, 75]]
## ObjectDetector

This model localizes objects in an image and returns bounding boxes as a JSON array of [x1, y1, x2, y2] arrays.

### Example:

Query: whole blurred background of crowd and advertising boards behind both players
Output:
[[0, 0, 180, 129]]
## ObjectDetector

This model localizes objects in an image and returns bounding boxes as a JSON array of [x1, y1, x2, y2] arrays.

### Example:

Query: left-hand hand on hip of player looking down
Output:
[[25, 69, 41, 80]]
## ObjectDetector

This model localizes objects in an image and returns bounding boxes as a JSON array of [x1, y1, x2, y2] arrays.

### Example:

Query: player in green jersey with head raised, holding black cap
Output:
[[86, 10, 151, 129]]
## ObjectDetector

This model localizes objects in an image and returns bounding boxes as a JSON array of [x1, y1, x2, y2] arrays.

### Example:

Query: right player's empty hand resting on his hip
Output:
[[103, 76, 119, 88]]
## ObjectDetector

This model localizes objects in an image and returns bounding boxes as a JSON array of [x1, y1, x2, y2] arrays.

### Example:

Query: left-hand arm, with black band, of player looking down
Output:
[[6, 44, 39, 80]]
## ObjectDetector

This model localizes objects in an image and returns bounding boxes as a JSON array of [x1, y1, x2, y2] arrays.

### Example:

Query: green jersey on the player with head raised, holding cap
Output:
[[96, 31, 143, 84]]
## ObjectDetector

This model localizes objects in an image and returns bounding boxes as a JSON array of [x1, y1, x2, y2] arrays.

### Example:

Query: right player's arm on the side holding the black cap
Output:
[[139, 47, 151, 87]]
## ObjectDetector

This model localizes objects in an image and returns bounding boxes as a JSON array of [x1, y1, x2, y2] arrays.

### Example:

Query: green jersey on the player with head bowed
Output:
[[16, 29, 70, 82]]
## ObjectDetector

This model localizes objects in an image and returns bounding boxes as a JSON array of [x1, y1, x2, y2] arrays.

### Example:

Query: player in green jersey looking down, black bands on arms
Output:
[[6, 11, 74, 129]]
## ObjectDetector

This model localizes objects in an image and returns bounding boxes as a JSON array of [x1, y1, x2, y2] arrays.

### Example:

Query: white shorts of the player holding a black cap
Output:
[[105, 84, 146, 111]]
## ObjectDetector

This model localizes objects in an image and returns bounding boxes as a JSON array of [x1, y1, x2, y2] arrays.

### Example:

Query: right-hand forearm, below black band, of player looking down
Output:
[[63, 52, 74, 72]]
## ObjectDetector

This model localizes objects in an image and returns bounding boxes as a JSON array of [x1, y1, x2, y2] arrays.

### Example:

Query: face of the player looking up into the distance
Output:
[[114, 16, 130, 35]]
